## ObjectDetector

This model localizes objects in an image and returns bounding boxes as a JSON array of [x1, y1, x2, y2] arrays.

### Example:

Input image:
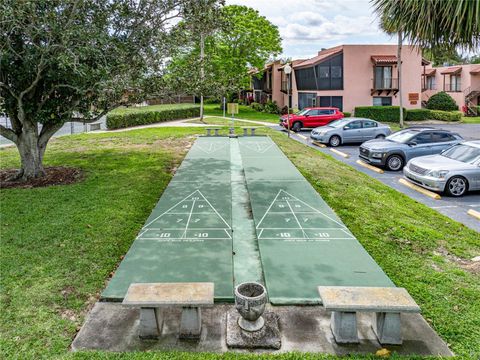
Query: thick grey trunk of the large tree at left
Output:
[[16, 123, 46, 181]]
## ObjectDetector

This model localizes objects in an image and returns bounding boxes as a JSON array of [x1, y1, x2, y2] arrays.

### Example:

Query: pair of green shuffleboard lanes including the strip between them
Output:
[[102, 136, 394, 304]]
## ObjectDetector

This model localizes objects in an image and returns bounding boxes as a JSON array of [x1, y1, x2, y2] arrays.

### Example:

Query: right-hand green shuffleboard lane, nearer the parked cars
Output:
[[239, 138, 394, 304]]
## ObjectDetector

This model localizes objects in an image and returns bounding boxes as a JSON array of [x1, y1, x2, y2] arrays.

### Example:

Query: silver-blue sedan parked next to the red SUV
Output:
[[310, 118, 392, 147]]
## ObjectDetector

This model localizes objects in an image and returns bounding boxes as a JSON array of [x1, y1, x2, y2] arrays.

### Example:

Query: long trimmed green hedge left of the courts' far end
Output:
[[107, 106, 200, 129]]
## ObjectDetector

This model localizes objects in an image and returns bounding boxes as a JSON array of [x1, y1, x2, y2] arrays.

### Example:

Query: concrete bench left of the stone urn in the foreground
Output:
[[123, 283, 214, 339]]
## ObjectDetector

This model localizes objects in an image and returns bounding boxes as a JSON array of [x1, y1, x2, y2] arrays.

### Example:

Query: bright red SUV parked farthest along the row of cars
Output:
[[280, 107, 343, 132]]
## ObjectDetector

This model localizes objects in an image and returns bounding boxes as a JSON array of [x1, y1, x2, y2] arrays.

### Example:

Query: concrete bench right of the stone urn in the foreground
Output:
[[318, 286, 420, 345]]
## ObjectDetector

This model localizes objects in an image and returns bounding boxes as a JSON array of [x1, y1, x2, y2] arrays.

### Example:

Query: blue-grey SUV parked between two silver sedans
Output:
[[359, 127, 463, 171]]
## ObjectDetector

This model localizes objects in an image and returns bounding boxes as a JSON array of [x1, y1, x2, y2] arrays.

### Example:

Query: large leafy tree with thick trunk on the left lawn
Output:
[[0, 0, 195, 180]]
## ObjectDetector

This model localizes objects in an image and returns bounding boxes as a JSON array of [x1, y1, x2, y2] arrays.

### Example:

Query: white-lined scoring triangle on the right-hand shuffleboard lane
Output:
[[256, 189, 354, 241]]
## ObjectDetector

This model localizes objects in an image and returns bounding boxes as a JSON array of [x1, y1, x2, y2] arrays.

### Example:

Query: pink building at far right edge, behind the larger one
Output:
[[422, 64, 480, 114]]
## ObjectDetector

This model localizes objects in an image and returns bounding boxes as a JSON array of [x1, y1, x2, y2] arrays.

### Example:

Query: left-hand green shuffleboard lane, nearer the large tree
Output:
[[102, 137, 233, 301]]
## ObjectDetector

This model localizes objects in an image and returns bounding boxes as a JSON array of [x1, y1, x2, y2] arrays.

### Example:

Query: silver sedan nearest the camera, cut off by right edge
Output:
[[403, 141, 480, 196]]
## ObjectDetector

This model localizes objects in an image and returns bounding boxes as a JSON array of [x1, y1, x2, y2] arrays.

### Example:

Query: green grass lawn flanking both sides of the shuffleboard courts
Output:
[[0, 128, 480, 360]]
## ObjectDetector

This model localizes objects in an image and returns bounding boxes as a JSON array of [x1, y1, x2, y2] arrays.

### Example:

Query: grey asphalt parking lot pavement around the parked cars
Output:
[[277, 124, 480, 232]]
